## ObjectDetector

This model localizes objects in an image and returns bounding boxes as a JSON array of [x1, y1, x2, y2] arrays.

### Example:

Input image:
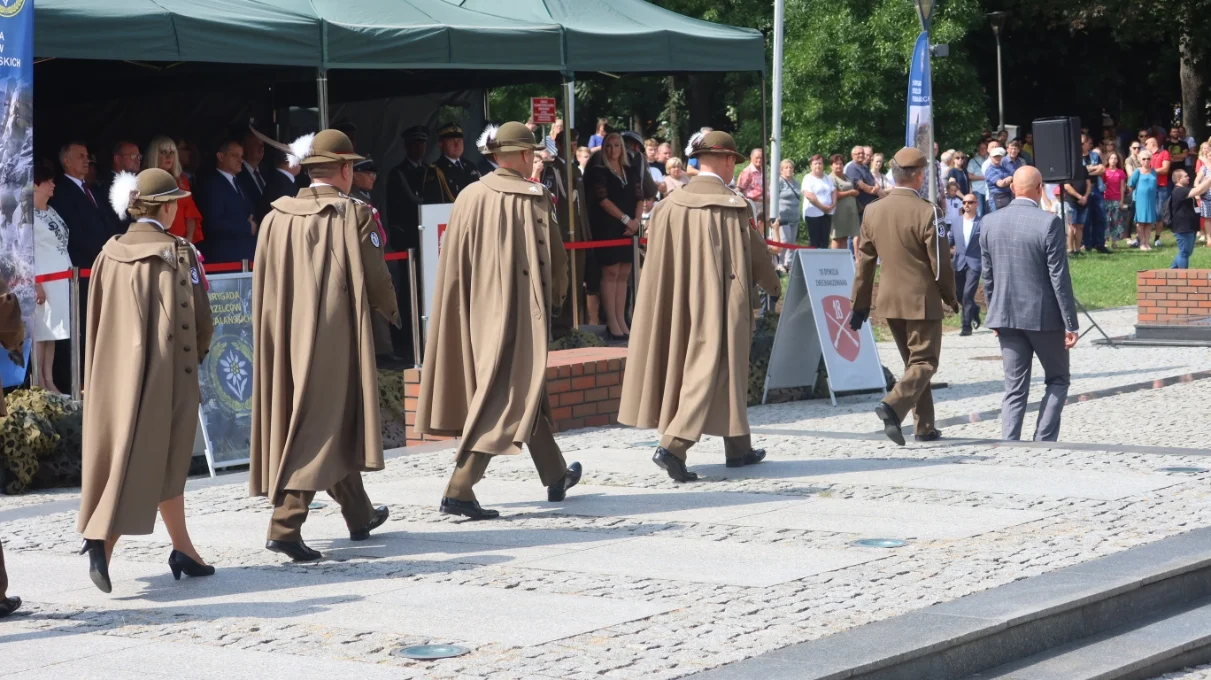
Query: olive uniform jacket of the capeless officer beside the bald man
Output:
[[853, 189, 955, 321]]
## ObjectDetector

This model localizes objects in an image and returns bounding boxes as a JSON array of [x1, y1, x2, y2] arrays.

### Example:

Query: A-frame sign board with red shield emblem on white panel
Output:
[[762, 249, 886, 405]]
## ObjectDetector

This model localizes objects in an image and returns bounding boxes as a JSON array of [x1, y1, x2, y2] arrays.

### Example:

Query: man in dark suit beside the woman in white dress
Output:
[[51, 142, 117, 267]]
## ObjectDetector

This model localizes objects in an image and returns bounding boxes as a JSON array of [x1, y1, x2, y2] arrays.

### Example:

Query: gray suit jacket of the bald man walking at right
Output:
[[980, 198, 1078, 330]]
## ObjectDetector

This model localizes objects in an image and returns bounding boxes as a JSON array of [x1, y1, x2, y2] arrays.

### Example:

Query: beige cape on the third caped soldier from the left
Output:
[[417, 168, 568, 455]]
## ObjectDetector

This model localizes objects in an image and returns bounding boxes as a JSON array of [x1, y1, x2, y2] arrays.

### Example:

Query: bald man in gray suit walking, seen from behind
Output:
[[980, 166, 1078, 442]]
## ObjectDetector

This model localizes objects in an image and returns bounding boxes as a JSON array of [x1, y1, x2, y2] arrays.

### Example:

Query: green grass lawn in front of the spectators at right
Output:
[[782, 231, 1211, 341]]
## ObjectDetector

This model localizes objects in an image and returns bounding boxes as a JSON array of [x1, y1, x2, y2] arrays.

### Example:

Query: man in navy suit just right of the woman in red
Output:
[[197, 139, 257, 263]]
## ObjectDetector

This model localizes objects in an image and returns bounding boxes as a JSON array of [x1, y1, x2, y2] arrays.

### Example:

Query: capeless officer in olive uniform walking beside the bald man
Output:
[[850, 146, 959, 445]]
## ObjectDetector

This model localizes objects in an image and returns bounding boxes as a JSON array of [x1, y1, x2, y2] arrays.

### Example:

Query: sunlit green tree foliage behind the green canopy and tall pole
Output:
[[492, 0, 987, 165]]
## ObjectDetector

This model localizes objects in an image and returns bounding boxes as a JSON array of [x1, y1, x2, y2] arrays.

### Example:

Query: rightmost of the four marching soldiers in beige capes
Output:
[[618, 132, 781, 482]]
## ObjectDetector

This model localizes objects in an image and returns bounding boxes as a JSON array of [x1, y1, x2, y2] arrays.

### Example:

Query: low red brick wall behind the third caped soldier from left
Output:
[[403, 347, 626, 444]]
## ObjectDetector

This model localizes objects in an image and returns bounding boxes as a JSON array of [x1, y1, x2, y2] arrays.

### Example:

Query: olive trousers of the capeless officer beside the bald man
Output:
[[883, 318, 942, 434]]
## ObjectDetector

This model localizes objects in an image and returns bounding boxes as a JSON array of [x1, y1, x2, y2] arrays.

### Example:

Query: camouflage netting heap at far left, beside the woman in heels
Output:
[[0, 387, 82, 495]]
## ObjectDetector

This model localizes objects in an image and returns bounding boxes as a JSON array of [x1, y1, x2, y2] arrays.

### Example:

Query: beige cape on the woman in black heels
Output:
[[78, 223, 213, 540]]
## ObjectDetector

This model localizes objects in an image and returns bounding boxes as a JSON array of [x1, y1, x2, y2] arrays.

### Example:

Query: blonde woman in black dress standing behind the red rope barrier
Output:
[[585, 132, 643, 340]]
